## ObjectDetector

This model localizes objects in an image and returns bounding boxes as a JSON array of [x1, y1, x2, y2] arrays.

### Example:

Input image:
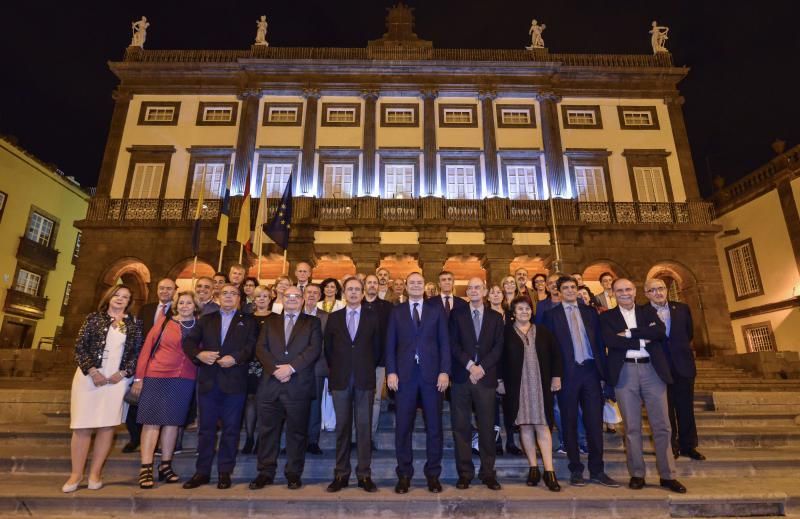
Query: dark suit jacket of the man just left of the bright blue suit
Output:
[[324, 305, 381, 390]]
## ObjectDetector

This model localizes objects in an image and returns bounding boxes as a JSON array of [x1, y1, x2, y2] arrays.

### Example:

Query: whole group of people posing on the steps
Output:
[[62, 262, 704, 494]]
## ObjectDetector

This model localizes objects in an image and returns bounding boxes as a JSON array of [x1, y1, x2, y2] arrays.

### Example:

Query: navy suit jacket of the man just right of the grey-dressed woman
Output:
[[542, 304, 608, 384]]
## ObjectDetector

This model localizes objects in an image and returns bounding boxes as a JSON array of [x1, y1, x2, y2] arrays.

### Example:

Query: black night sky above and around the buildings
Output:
[[0, 0, 800, 195]]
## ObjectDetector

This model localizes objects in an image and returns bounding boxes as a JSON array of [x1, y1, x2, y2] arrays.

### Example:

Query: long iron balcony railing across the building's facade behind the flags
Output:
[[86, 197, 714, 225]]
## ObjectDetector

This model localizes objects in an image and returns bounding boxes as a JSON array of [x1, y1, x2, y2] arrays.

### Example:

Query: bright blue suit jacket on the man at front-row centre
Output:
[[386, 299, 451, 384]]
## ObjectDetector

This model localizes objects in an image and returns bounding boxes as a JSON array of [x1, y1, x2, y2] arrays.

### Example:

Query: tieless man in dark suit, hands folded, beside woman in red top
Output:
[[183, 283, 258, 489]]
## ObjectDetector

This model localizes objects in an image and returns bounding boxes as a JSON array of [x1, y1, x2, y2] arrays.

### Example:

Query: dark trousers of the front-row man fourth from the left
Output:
[[256, 392, 312, 478]]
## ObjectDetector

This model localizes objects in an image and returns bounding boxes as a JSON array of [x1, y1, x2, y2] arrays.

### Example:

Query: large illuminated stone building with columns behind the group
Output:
[[64, 6, 734, 354]]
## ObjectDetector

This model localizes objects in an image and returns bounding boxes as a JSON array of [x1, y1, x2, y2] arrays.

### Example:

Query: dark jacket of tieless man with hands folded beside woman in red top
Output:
[[183, 310, 258, 394]]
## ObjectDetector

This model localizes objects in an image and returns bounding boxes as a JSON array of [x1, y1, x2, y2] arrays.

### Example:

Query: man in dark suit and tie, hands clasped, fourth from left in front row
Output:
[[250, 286, 322, 490]]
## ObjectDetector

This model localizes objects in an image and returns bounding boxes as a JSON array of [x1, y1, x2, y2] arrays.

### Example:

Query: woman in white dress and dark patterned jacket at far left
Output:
[[62, 285, 142, 492]]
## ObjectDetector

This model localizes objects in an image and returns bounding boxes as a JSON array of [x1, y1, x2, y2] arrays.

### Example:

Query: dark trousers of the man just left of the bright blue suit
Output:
[[331, 382, 375, 479]]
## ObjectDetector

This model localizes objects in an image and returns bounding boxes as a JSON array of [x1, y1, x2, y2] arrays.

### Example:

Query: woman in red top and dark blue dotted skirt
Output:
[[133, 290, 200, 488]]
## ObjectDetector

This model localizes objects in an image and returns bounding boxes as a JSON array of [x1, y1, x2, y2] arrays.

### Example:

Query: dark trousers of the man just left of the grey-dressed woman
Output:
[[450, 382, 497, 480]]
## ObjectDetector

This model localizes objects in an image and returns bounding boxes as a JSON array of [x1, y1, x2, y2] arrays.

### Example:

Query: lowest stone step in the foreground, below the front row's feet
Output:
[[0, 475, 800, 519]]
